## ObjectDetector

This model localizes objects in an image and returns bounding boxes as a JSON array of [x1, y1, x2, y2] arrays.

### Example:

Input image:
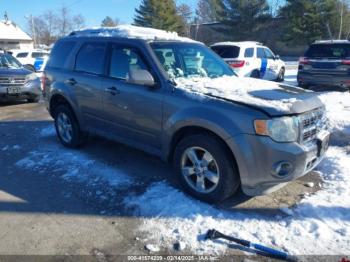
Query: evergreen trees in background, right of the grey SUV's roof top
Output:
[[134, 0, 350, 45]]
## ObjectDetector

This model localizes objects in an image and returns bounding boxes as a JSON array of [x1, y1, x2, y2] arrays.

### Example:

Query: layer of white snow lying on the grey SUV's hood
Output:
[[175, 76, 298, 112]]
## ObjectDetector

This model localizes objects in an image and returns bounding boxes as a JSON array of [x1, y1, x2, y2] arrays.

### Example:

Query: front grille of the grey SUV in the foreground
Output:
[[300, 108, 327, 144]]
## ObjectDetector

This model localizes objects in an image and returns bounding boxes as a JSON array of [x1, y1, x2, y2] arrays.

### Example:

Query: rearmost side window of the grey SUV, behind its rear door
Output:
[[47, 41, 75, 68]]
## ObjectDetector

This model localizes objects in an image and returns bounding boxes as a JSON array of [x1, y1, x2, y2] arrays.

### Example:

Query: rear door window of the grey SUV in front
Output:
[[75, 43, 106, 75]]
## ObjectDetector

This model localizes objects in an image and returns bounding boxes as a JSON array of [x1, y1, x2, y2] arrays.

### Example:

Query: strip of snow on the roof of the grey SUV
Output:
[[70, 25, 195, 42]]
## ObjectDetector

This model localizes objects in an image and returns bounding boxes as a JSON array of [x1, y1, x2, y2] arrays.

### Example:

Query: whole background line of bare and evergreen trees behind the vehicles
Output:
[[28, 0, 350, 45]]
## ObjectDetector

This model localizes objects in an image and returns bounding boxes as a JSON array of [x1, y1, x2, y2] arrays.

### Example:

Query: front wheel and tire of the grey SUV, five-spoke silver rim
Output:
[[174, 134, 240, 203]]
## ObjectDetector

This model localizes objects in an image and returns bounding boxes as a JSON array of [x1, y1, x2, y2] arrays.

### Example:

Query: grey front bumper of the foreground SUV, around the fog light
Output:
[[227, 134, 324, 196]]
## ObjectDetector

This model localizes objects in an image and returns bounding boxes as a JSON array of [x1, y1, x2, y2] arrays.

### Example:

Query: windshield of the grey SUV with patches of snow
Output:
[[151, 42, 235, 78]]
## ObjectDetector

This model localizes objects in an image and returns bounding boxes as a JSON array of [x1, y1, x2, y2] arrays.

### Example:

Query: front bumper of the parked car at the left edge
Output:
[[0, 78, 42, 101]]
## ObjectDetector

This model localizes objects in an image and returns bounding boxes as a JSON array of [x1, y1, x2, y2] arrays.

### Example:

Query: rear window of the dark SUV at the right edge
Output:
[[305, 44, 350, 59]]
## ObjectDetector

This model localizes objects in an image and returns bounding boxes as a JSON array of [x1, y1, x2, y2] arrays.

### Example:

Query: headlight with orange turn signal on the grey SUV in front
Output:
[[254, 117, 299, 142]]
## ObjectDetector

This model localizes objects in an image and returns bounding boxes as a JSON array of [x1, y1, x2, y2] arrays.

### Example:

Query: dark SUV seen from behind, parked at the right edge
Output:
[[297, 40, 350, 90]]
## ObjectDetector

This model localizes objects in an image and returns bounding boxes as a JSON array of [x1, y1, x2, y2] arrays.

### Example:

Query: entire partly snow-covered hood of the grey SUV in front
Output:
[[175, 76, 323, 116]]
